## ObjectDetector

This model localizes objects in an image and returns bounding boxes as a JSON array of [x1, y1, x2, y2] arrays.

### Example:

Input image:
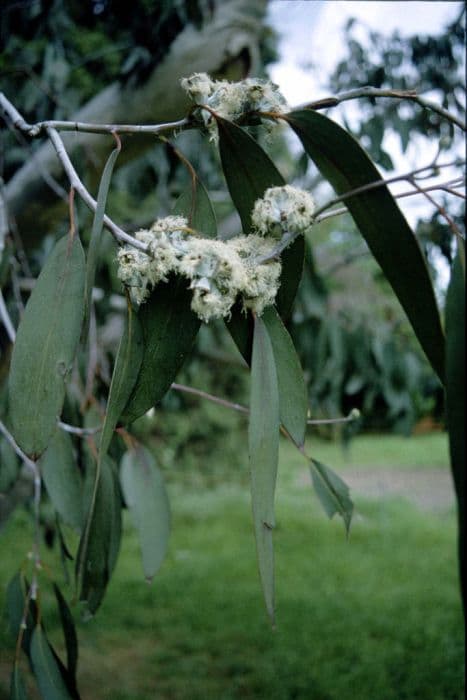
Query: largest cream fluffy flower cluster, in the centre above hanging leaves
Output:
[[118, 216, 281, 322]]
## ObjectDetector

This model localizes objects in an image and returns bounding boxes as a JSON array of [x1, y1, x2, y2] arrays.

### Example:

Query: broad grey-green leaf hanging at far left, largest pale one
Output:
[[9, 236, 85, 458]]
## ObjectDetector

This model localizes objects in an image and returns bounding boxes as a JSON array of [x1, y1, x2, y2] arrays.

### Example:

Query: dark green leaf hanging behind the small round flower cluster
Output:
[[217, 118, 304, 326]]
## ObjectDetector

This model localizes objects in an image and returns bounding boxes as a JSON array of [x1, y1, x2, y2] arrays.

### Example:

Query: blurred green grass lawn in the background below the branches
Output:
[[0, 435, 464, 700]]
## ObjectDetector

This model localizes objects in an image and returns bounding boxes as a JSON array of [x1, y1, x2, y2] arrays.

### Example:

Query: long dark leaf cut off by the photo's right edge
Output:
[[446, 249, 466, 610]]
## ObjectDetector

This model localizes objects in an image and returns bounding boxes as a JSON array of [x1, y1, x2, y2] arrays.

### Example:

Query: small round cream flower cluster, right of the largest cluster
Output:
[[251, 185, 315, 238]]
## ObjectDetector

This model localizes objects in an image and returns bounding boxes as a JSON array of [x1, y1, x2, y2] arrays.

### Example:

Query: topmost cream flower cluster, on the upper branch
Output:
[[181, 73, 287, 140]]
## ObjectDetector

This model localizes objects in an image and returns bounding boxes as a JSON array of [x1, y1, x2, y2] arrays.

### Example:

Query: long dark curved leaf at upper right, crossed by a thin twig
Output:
[[287, 110, 445, 381]]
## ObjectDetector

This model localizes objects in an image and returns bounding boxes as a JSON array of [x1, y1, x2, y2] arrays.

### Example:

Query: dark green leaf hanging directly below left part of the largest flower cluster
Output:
[[122, 277, 200, 423]]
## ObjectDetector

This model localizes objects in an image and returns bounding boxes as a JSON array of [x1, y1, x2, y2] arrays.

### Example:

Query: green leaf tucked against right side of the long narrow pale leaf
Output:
[[262, 307, 308, 447]]
